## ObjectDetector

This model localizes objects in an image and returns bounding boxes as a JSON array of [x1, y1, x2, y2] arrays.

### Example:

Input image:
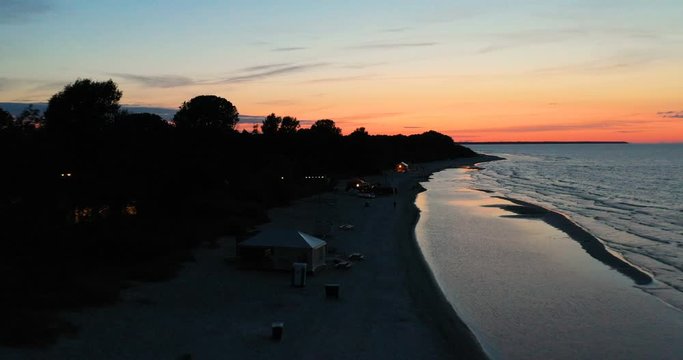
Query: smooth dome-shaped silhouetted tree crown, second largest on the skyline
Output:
[[173, 95, 239, 130]]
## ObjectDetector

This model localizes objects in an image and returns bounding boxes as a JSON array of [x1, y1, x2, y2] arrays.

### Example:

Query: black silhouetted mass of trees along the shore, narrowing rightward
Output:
[[0, 79, 475, 344]]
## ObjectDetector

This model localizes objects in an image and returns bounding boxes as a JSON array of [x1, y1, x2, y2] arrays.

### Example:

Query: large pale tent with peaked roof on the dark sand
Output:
[[238, 229, 327, 272]]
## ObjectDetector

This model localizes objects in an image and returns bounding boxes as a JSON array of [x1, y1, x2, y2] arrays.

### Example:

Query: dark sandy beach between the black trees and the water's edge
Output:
[[0, 158, 488, 359]]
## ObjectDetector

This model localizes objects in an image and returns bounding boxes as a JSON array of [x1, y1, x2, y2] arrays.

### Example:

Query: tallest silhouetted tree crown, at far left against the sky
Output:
[[45, 79, 122, 131]]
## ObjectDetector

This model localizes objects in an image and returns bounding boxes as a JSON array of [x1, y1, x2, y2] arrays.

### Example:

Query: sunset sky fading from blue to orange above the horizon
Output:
[[0, 0, 683, 142]]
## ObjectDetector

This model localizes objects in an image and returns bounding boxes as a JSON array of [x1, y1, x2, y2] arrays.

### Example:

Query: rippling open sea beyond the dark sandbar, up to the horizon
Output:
[[470, 144, 683, 308]]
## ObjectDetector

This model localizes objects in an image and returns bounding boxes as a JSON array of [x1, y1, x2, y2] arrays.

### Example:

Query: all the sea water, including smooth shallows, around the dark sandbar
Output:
[[416, 144, 683, 359]]
